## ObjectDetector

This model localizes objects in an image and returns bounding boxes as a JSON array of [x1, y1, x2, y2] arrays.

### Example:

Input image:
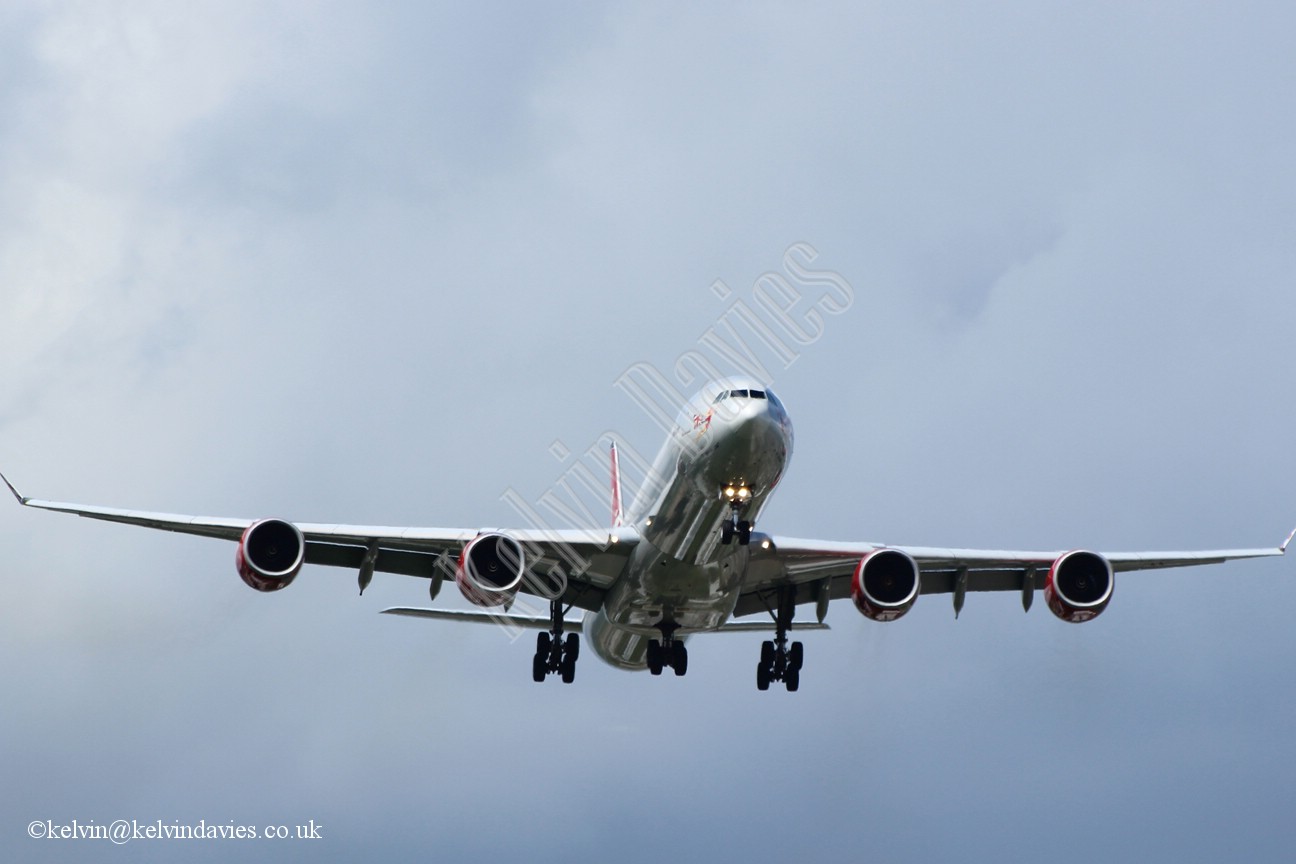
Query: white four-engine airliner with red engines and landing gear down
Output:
[[0, 378, 1296, 692]]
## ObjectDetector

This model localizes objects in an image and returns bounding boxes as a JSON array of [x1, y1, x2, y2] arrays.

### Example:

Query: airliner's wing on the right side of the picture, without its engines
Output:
[[734, 531, 1296, 617]]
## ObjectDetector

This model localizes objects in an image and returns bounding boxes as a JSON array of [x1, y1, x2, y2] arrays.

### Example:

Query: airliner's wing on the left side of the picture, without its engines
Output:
[[0, 475, 639, 610]]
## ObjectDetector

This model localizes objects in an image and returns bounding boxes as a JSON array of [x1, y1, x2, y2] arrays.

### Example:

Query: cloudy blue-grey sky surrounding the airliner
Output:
[[0, 1, 1296, 864]]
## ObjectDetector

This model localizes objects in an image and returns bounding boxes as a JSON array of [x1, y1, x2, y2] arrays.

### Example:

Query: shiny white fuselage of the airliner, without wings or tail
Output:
[[584, 381, 793, 668]]
